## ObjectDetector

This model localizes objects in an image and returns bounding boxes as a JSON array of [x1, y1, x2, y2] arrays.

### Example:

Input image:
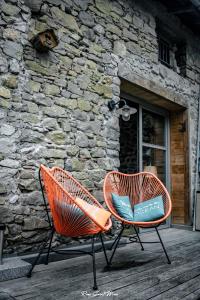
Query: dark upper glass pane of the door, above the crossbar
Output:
[[142, 109, 165, 146]]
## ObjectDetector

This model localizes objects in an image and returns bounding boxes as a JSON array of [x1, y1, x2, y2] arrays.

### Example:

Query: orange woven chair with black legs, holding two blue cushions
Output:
[[104, 171, 172, 267]]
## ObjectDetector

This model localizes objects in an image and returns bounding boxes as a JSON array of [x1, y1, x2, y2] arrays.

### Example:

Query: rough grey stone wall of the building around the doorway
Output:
[[0, 0, 200, 253]]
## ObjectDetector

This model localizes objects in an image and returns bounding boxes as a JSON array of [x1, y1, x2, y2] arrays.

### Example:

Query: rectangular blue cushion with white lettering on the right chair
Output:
[[133, 196, 165, 222]]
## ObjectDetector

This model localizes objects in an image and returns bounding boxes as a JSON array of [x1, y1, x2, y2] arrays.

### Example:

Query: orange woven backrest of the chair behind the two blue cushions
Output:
[[104, 171, 171, 223]]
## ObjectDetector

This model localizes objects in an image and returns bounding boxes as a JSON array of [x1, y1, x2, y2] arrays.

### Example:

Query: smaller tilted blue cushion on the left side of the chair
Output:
[[112, 193, 133, 221]]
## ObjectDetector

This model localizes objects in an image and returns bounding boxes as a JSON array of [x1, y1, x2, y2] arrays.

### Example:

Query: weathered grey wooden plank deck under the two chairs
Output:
[[0, 229, 200, 300]]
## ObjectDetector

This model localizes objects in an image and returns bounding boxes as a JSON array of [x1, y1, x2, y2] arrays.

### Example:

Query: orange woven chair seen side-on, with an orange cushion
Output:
[[27, 165, 112, 290]]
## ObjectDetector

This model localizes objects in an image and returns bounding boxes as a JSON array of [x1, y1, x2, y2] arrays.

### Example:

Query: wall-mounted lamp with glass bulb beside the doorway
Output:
[[108, 99, 137, 121]]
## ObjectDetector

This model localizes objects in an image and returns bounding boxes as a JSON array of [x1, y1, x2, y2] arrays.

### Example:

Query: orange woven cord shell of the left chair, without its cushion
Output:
[[40, 165, 111, 236]]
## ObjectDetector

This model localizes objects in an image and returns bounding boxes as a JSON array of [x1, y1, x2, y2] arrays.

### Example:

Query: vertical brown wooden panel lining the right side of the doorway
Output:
[[170, 111, 189, 224]]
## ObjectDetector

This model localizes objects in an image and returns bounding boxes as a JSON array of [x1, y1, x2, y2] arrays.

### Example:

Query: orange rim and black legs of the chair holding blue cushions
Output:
[[103, 171, 172, 269]]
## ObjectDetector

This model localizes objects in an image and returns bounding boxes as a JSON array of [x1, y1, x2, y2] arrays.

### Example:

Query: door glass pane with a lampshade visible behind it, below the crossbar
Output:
[[143, 147, 166, 184]]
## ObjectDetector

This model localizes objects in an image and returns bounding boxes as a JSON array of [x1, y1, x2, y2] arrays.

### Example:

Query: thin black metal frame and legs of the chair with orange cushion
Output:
[[27, 165, 112, 290]]
